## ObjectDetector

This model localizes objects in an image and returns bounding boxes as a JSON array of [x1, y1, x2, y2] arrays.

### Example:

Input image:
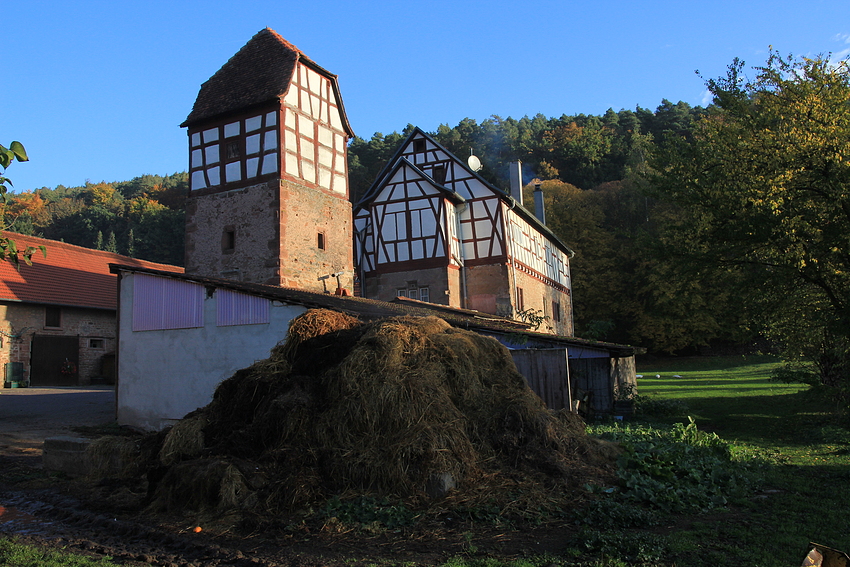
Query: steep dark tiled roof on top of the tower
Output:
[[180, 28, 354, 136]]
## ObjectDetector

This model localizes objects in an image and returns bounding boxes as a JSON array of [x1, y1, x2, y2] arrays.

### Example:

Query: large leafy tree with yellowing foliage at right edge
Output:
[[655, 51, 850, 400]]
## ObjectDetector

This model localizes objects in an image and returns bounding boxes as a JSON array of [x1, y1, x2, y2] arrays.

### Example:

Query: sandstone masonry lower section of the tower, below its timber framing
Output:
[[186, 180, 354, 293]]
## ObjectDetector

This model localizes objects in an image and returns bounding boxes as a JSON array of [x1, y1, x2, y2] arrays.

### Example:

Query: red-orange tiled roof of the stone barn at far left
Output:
[[0, 232, 183, 310]]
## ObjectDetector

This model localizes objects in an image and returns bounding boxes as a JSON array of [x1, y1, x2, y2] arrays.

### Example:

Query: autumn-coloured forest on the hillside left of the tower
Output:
[[5, 172, 188, 266]]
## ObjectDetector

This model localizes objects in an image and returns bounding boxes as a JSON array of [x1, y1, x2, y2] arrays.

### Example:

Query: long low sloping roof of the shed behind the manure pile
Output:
[[110, 264, 638, 356]]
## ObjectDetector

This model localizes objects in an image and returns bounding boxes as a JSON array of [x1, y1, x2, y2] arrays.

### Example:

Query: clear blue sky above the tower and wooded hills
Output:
[[0, 0, 850, 191]]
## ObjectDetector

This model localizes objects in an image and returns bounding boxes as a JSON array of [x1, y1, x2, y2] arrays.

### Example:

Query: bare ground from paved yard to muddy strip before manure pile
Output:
[[0, 387, 572, 567]]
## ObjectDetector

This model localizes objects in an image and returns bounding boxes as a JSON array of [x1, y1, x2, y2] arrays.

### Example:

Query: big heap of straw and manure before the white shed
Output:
[[139, 310, 610, 515]]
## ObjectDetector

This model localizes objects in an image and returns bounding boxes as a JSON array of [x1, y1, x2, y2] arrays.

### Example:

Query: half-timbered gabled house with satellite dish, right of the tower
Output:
[[354, 128, 573, 336]]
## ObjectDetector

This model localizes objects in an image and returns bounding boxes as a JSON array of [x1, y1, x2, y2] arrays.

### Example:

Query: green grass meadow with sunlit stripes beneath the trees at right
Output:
[[638, 357, 850, 566]]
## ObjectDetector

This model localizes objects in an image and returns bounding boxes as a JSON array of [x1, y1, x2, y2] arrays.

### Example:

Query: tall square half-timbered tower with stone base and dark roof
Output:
[[181, 28, 353, 291]]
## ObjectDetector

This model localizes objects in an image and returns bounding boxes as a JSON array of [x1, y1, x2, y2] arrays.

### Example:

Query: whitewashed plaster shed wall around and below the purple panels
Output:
[[117, 273, 307, 430]]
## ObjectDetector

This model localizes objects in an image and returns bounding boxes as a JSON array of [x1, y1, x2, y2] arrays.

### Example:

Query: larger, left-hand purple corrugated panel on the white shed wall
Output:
[[133, 274, 204, 331]]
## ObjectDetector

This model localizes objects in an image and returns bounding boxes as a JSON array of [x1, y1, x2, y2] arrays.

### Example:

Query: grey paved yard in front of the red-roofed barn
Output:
[[0, 386, 115, 456]]
